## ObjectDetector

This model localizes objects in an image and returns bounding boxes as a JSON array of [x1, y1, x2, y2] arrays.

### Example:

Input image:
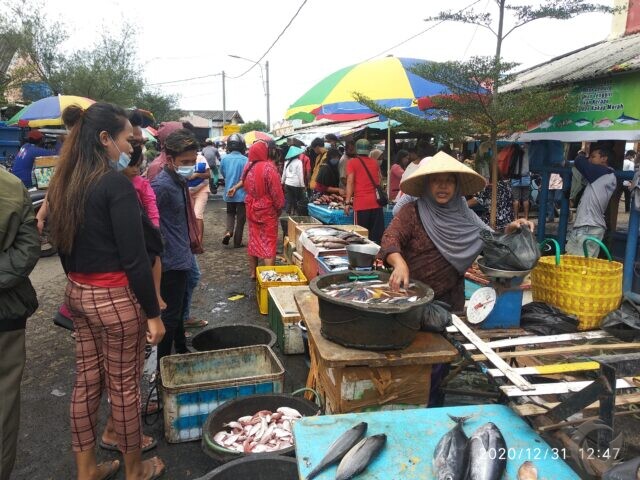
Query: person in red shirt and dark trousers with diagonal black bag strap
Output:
[[344, 138, 384, 243]]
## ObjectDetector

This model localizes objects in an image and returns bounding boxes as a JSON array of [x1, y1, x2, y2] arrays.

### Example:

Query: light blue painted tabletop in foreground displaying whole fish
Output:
[[293, 405, 580, 480]]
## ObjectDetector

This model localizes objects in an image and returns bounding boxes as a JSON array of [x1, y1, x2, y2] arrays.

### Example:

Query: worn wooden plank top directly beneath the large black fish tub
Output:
[[295, 292, 458, 368]]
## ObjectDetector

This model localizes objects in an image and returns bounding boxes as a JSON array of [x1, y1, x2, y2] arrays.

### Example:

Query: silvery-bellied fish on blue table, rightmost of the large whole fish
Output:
[[467, 422, 507, 480]]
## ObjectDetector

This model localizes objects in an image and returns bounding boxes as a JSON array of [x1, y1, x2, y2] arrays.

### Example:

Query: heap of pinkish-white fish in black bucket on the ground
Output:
[[213, 407, 302, 453]]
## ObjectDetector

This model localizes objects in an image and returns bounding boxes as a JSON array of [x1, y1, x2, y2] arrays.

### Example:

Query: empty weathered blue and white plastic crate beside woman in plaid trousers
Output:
[[160, 345, 284, 443]]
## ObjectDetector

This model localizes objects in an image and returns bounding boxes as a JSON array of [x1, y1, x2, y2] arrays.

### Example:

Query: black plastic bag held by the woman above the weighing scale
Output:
[[480, 225, 540, 271]]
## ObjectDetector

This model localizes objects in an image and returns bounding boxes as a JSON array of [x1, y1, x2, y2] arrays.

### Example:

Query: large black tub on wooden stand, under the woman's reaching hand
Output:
[[309, 271, 434, 350]]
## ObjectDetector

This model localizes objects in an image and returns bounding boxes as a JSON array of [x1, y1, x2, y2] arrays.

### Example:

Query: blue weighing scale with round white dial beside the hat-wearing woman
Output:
[[467, 258, 531, 329]]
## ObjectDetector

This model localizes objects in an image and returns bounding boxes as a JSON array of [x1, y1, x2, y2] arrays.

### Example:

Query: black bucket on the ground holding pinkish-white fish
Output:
[[202, 394, 320, 464]]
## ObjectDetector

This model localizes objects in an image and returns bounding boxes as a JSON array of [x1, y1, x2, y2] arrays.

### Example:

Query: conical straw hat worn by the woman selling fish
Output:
[[400, 152, 487, 197]]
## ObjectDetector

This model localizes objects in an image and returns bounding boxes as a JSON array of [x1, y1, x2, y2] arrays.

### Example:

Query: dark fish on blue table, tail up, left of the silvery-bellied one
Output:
[[433, 415, 470, 480]]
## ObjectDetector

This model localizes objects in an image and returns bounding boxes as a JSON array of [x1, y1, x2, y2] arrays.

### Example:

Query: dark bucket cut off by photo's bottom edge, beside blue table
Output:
[[195, 454, 299, 480]]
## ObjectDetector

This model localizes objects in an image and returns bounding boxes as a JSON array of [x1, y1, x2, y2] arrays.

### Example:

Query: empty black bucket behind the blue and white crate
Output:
[[191, 324, 276, 352]]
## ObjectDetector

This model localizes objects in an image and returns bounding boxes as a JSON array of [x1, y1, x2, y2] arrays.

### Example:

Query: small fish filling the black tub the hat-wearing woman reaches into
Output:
[[322, 280, 422, 305]]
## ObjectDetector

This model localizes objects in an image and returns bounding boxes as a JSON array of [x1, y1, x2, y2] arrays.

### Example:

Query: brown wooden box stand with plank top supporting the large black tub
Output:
[[295, 292, 458, 413]]
